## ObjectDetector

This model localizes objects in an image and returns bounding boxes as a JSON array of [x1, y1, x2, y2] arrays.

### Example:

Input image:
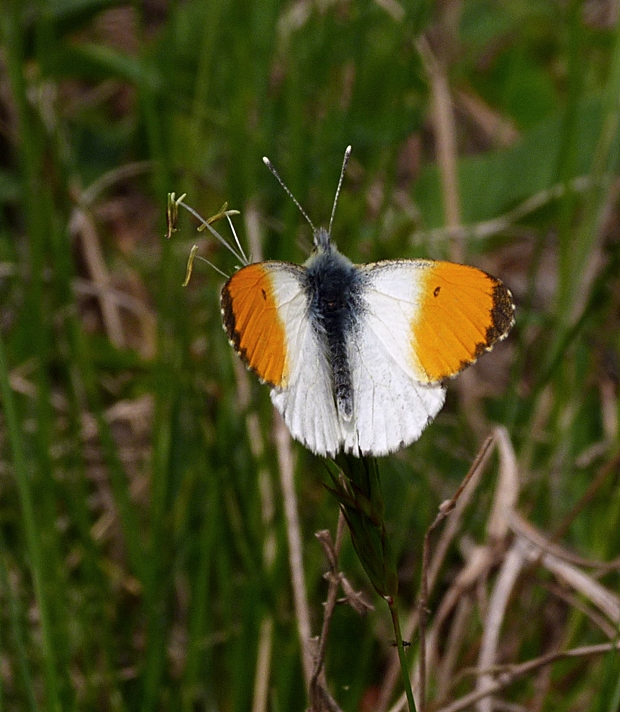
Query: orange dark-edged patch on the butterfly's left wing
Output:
[[221, 263, 288, 388]]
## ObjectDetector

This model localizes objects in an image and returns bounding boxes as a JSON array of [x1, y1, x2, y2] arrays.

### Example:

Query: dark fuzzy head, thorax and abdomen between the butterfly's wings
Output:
[[304, 236, 363, 421]]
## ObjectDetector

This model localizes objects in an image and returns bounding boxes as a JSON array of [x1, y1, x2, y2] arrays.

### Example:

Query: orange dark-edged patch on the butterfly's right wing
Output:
[[412, 262, 514, 383]]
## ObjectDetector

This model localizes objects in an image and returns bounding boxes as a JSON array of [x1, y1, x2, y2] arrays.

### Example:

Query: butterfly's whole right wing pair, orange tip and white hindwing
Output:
[[349, 260, 514, 455]]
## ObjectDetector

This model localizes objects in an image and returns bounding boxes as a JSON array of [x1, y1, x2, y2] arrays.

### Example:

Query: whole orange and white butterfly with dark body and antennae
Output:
[[221, 146, 514, 456]]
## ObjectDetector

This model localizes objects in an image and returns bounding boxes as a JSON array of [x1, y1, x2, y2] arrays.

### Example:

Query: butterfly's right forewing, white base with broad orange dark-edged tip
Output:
[[361, 260, 514, 383]]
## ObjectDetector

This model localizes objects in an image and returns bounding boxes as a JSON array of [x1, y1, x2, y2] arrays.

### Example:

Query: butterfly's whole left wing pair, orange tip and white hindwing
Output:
[[221, 262, 343, 455]]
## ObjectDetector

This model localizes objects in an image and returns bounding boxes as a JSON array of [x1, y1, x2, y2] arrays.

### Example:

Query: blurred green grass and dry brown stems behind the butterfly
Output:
[[0, 0, 620, 712]]
